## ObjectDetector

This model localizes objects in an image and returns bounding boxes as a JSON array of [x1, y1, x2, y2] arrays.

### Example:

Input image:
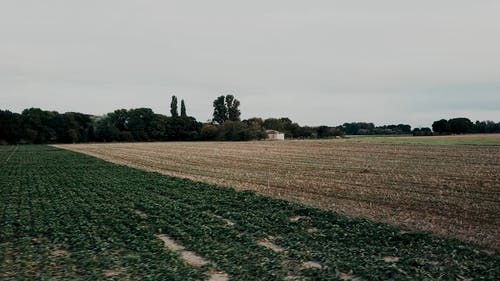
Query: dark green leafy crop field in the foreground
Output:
[[0, 146, 500, 280]]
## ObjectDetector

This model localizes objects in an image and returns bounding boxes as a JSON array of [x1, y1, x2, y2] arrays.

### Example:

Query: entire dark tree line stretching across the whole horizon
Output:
[[0, 95, 500, 144]]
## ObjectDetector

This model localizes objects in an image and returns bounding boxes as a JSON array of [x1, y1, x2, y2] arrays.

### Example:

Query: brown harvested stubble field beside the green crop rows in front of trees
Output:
[[59, 136, 500, 249]]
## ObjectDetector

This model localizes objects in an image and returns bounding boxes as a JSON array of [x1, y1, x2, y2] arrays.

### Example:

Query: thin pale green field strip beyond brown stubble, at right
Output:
[[346, 134, 500, 146]]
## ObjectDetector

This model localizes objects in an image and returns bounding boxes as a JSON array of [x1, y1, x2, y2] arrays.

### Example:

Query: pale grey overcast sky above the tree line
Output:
[[0, 0, 500, 127]]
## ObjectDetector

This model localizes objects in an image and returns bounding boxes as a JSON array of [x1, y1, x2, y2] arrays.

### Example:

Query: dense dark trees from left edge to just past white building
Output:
[[0, 106, 343, 144]]
